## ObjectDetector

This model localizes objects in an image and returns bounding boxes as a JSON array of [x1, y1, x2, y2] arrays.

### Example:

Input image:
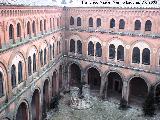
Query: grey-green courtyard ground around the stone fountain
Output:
[[47, 94, 160, 120]]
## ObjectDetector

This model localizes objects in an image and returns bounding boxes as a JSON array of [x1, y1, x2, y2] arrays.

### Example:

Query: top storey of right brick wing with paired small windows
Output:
[[66, 7, 160, 37]]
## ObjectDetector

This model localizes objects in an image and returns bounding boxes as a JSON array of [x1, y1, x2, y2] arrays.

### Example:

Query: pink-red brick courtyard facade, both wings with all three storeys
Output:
[[0, 0, 160, 120]]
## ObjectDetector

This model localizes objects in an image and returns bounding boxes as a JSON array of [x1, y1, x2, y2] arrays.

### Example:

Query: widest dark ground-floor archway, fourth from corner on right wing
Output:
[[129, 77, 148, 104]]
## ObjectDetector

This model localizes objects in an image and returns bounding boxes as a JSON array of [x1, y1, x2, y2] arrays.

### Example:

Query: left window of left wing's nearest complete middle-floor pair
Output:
[[11, 65, 16, 88]]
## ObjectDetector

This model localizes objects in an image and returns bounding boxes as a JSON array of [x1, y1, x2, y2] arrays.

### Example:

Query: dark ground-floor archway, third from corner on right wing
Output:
[[107, 72, 123, 99]]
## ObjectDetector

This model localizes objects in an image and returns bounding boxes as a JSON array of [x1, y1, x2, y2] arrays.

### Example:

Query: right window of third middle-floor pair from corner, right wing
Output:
[[117, 45, 124, 61]]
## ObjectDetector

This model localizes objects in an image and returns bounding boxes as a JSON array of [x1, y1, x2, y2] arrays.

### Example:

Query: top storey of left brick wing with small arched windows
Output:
[[0, 6, 64, 51]]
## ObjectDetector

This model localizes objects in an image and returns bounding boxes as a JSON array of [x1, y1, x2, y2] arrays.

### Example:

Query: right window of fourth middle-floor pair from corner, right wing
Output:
[[142, 48, 150, 65]]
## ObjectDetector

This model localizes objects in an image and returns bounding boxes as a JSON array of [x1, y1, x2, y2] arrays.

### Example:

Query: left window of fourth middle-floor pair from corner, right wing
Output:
[[132, 47, 140, 63]]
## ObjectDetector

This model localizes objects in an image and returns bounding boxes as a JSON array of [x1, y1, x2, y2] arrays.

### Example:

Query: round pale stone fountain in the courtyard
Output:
[[70, 84, 93, 110]]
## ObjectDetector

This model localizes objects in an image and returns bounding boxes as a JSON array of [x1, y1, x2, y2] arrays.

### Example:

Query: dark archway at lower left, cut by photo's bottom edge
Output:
[[16, 102, 29, 120]]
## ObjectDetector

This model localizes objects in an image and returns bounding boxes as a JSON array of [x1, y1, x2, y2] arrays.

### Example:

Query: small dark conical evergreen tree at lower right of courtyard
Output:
[[142, 86, 155, 117]]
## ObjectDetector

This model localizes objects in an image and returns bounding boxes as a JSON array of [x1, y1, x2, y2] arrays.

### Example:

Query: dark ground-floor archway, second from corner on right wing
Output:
[[88, 68, 101, 92]]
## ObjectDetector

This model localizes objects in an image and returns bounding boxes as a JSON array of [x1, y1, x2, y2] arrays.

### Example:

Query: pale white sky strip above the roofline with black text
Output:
[[0, 0, 160, 8]]
